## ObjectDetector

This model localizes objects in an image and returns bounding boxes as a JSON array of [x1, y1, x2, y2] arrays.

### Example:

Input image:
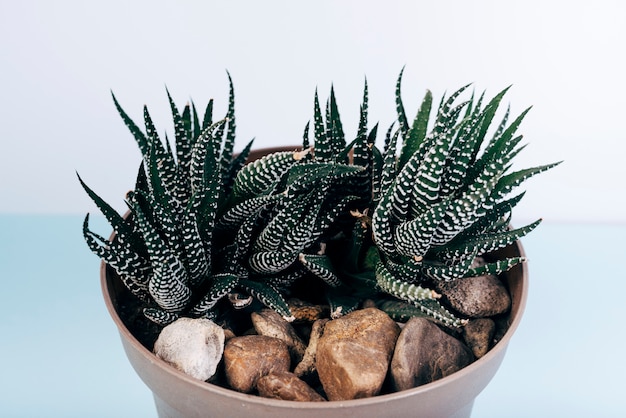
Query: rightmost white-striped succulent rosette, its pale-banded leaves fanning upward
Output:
[[371, 73, 558, 326]]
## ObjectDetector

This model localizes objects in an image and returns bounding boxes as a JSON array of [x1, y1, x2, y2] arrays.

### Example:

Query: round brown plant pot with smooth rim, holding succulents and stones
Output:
[[100, 148, 528, 418]]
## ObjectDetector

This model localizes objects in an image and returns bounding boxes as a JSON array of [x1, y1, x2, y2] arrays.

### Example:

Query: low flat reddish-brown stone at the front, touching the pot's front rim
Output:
[[257, 372, 326, 402]]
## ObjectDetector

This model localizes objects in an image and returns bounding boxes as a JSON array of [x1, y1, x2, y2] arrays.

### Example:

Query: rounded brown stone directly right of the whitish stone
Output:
[[224, 335, 291, 393]]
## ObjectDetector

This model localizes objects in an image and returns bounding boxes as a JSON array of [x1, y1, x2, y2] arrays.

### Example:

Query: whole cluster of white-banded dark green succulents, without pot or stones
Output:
[[79, 69, 556, 326]]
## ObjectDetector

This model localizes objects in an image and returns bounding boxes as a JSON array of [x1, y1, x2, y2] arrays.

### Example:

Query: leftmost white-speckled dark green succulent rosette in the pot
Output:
[[79, 76, 258, 325]]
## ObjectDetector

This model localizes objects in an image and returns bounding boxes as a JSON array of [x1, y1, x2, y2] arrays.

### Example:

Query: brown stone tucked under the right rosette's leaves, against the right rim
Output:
[[437, 275, 511, 318]]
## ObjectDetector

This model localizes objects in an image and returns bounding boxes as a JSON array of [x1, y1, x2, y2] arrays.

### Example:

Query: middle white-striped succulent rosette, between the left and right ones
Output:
[[218, 83, 375, 319]]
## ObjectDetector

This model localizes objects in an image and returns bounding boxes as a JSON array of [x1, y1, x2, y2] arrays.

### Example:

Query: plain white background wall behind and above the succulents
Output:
[[0, 0, 626, 222]]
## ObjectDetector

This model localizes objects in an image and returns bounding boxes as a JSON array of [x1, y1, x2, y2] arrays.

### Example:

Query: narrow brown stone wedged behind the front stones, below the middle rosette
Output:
[[250, 309, 306, 364]]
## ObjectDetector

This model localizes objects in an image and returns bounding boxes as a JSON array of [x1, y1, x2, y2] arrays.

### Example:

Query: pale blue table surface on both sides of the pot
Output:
[[0, 215, 626, 418]]
